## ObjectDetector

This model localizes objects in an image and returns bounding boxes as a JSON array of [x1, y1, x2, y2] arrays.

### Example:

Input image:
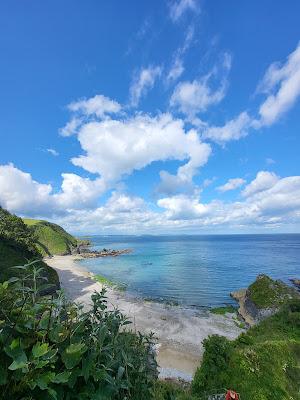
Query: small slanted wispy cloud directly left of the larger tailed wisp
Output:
[[130, 66, 162, 107]]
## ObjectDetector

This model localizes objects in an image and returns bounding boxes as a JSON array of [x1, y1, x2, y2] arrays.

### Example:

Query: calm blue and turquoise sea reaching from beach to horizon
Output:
[[81, 234, 300, 307]]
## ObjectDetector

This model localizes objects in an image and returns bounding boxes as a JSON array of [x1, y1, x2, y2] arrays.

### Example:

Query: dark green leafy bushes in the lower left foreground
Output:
[[0, 263, 157, 400]]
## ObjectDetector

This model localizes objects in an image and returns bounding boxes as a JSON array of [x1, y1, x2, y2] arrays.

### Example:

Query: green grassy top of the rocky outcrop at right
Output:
[[247, 275, 298, 309]]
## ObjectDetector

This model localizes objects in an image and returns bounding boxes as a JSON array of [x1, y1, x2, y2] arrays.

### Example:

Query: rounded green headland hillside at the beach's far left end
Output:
[[23, 219, 77, 256]]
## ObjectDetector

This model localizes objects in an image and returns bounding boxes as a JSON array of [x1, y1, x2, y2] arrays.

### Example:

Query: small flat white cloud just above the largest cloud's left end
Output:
[[68, 94, 122, 118]]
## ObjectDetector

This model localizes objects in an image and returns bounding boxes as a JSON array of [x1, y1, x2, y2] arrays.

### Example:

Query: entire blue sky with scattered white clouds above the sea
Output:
[[0, 0, 300, 234]]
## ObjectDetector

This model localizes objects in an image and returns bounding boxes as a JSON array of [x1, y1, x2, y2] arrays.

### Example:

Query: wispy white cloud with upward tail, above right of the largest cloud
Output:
[[170, 53, 231, 118]]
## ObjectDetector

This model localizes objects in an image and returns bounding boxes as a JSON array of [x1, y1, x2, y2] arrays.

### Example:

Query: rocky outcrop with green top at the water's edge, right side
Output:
[[230, 275, 300, 326]]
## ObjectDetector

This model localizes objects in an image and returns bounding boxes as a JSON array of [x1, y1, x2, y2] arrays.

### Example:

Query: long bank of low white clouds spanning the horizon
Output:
[[0, 164, 300, 233]]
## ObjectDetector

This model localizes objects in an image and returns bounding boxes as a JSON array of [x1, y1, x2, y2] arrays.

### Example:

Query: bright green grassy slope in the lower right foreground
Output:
[[193, 299, 300, 400]]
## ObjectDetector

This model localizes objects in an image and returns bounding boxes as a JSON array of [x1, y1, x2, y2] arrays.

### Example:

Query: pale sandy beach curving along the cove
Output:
[[45, 256, 242, 380]]
